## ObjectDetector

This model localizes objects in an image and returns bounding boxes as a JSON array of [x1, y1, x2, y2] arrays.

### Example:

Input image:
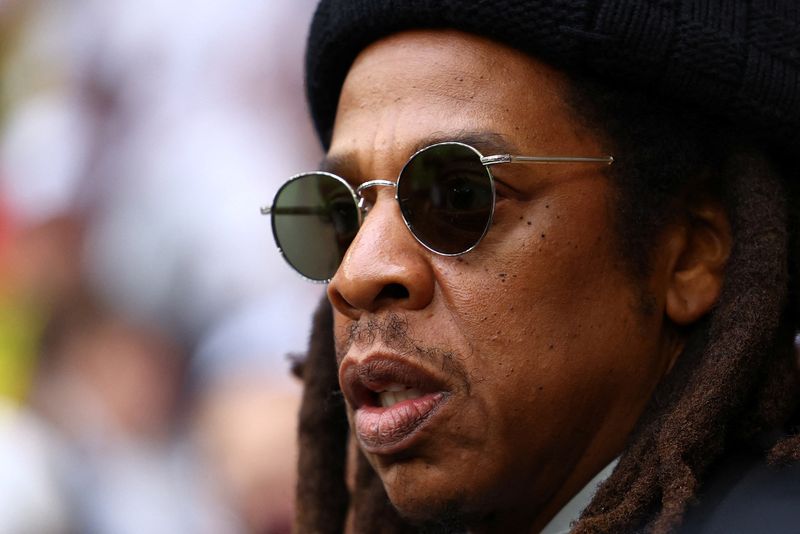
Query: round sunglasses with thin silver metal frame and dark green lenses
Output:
[[261, 141, 614, 283]]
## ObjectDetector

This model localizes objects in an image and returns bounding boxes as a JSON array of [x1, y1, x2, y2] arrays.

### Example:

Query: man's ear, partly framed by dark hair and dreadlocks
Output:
[[666, 202, 732, 325]]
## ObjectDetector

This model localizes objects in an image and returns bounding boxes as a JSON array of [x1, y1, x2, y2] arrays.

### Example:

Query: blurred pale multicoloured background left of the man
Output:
[[0, 0, 322, 534]]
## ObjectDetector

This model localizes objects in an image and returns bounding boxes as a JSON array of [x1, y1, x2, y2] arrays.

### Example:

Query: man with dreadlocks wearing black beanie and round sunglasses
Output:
[[269, 0, 800, 532]]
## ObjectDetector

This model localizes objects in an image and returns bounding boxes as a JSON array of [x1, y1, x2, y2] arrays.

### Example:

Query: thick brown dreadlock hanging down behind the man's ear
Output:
[[575, 148, 796, 533]]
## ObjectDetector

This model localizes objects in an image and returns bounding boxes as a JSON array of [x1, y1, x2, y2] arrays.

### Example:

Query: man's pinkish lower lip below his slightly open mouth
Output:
[[354, 392, 445, 454]]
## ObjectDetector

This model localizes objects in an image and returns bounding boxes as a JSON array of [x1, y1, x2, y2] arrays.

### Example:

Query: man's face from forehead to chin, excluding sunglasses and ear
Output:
[[328, 31, 673, 530]]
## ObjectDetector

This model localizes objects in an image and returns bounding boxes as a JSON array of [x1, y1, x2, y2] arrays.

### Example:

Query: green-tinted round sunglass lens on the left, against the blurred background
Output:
[[271, 173, 359, 281]]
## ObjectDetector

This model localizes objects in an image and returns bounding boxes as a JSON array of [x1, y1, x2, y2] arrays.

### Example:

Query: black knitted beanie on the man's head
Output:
[[306, 0, 800, 155]]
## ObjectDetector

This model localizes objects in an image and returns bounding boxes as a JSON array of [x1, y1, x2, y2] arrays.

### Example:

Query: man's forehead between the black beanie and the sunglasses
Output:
[[322, 30, 599, 178]]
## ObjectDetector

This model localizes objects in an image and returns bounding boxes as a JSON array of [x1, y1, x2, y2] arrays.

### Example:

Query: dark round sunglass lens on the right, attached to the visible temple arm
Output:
[[397, 143, 494, 254]]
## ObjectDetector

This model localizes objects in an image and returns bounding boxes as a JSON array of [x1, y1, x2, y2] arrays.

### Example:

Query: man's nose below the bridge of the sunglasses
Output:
[[328, 192, 434, 319]]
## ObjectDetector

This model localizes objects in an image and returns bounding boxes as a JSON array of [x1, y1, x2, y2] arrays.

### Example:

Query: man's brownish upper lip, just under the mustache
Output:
[[339, 354, 449, 409]]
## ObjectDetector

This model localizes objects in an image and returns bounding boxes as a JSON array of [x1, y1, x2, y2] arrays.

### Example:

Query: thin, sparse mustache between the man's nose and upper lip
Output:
[[335, 313, 475, 393]]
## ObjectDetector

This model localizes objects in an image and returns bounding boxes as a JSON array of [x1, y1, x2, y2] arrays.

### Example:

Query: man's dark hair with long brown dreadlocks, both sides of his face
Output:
[[296, 73, 800, 534]]
